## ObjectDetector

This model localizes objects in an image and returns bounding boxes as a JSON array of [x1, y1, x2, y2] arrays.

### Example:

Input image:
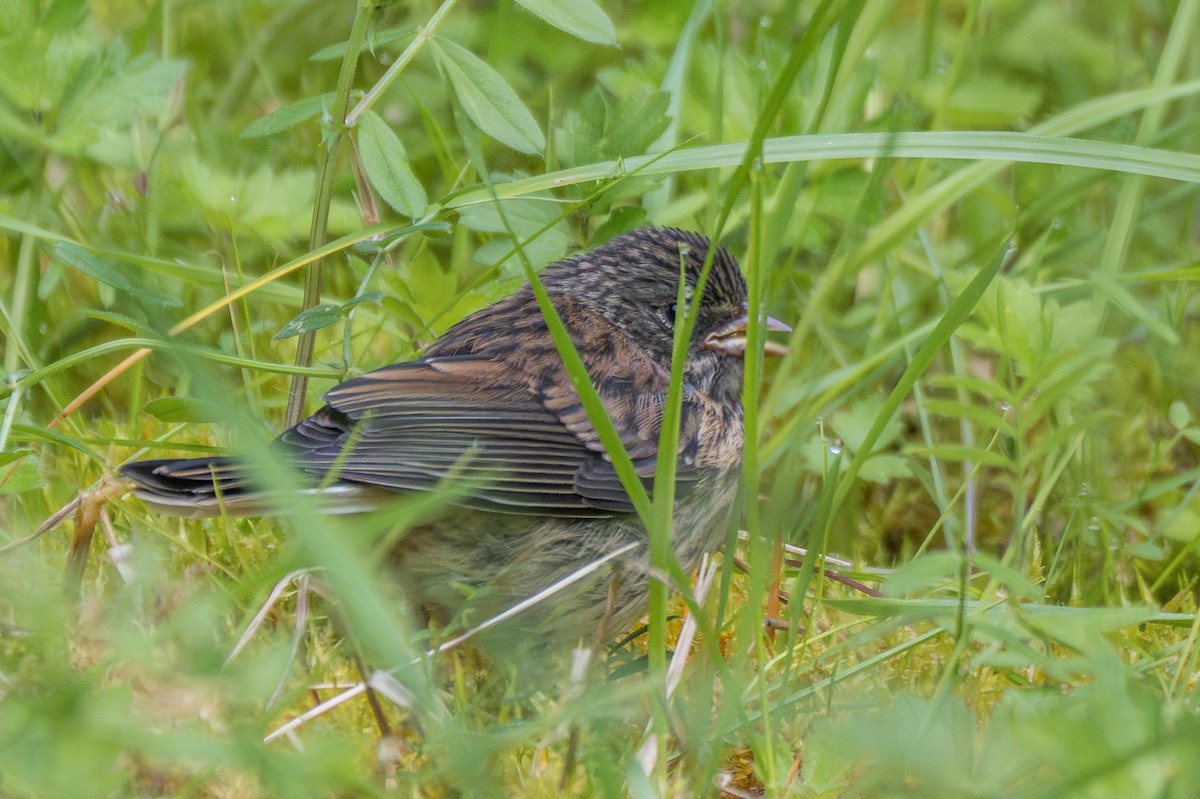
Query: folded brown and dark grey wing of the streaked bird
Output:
[[281, 355, 700, 517]]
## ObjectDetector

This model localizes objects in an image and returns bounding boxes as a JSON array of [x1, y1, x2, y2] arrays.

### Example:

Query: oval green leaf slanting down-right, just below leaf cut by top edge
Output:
[[430, 38, 546, 155]]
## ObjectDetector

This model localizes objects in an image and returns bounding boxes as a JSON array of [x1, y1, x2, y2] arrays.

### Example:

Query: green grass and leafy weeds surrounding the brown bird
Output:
[[0, 0, 1200, 797]]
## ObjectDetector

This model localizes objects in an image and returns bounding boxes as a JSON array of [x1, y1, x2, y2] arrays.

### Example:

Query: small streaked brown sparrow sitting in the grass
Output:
[[120, 228, 791, 652]]
